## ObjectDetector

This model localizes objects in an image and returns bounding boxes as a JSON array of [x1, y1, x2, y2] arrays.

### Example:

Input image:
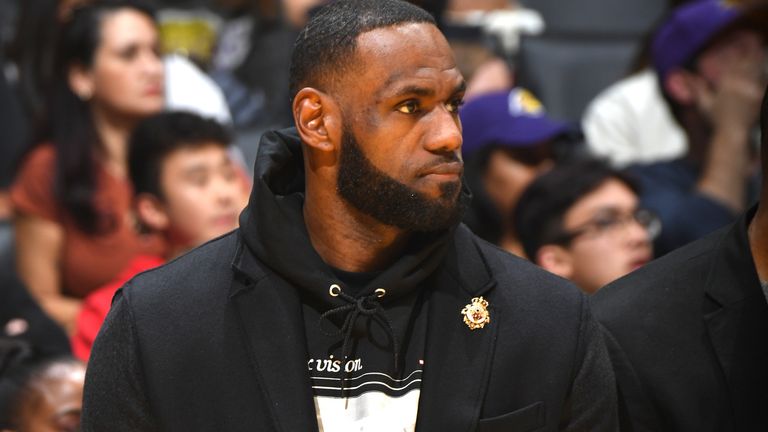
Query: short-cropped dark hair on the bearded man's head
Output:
[[289, 0, 437, 98]]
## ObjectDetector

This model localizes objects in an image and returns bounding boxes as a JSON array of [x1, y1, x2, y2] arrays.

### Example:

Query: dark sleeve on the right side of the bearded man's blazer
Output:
[[560, 300, 618, 432]]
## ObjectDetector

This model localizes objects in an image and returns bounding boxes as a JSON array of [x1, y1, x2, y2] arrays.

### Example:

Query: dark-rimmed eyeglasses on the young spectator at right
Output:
[[552, 209, 661, 245]]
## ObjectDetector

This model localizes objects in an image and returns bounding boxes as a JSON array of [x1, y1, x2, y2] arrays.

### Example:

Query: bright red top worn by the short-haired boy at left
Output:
[[72, 256, 165, 361]]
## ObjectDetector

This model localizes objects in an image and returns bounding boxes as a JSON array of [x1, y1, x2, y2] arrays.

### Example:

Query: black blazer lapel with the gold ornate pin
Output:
[[416, 227, 496, 432]]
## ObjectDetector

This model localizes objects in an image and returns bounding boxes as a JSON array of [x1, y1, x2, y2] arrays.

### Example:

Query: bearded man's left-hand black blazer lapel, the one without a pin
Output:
[[230, 243, 318, 432]]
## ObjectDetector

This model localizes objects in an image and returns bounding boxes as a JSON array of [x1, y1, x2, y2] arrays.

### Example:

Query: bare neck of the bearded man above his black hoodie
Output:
[[303, 191, 410, 272]]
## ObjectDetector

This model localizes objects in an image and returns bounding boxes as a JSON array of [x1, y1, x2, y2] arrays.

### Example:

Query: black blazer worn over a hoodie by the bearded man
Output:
[[82, 227, 617, 432]]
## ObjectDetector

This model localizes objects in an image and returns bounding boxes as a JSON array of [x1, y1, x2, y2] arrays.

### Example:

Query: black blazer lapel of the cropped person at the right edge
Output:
[[704, 215, 768, 427]]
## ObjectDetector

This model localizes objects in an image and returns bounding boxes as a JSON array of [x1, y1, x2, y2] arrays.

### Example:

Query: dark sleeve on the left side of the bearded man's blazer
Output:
[[82, 284, 160, 432]]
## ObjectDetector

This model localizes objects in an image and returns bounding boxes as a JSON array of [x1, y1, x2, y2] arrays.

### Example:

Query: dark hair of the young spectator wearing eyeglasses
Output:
[[514, 159, 639, 261]]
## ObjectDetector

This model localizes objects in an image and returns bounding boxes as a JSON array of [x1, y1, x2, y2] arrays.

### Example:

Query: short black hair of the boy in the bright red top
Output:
[[128, 111, 231, 197]]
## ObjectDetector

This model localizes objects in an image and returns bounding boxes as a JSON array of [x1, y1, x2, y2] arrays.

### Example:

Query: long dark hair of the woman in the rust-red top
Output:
[[37, 0, 154, 233]]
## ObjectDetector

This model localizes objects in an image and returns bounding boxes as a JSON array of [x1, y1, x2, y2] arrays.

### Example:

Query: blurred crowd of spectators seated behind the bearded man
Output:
[[0, 0, 768, 430]]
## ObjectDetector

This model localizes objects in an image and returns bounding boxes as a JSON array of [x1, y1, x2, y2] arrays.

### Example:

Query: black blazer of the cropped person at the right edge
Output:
[[592, 210, 768, 432]]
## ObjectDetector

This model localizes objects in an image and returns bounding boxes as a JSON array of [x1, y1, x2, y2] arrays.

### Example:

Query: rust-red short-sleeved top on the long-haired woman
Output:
[[11, 144, 164, 298]]
